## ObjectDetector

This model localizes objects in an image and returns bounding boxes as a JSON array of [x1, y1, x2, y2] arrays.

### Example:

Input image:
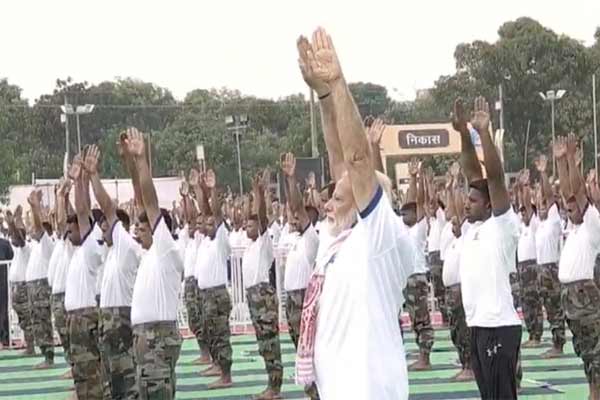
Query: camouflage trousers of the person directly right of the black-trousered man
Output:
[[518, 261, 544, 341]]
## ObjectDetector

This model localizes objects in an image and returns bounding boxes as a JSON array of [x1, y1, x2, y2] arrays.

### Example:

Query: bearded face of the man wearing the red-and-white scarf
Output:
[[325, 174, 356, 236]]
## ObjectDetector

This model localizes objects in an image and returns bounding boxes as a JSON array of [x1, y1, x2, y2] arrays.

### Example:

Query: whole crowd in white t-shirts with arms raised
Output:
[[4, 28, 600, 400]]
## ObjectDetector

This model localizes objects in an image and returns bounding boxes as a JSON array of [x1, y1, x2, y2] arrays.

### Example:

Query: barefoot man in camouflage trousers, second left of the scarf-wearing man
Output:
[[242, 176, 283, 400]]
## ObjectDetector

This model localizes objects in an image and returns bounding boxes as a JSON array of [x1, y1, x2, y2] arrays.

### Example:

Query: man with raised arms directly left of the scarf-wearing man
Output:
[[281, 153, 319, 349]]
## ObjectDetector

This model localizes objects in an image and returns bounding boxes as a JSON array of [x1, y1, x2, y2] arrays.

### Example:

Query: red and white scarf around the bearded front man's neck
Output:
[[296, 229, 352, 385]]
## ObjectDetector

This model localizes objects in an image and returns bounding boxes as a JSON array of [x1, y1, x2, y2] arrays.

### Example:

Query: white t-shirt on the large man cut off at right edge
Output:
[[558, 205, 600, 283]]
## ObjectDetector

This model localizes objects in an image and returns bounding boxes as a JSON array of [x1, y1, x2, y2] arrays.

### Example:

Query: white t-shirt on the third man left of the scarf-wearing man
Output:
[[196, 224, 231, 289]]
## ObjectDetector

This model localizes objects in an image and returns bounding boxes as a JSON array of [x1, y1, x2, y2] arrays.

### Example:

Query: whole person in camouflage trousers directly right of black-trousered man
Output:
[[510, 169, 544, 348]]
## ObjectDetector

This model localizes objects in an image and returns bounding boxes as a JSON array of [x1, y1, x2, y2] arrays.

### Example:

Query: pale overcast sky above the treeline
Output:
[[0, 0, 600, 101]]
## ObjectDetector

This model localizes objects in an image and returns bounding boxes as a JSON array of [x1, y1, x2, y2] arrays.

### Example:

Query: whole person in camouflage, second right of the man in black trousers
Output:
[[535, 155, 566, 358]]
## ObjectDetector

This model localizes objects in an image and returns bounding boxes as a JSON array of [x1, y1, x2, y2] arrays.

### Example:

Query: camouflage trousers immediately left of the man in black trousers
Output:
[[446, 284, 471, 369]]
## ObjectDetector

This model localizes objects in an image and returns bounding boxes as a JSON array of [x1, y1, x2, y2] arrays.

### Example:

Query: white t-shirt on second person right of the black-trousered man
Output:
[[535, 204, 562, 265]]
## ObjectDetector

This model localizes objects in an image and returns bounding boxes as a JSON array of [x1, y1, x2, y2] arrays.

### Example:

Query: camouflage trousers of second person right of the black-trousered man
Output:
[[539, 264, 566, 348]]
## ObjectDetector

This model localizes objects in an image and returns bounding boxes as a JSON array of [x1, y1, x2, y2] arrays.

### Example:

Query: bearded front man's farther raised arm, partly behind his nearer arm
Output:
[[297, 36, 346, 182]]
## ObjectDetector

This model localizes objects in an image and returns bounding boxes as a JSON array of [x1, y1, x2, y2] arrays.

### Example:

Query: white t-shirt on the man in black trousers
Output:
[[460, 207, 521, 328]]
